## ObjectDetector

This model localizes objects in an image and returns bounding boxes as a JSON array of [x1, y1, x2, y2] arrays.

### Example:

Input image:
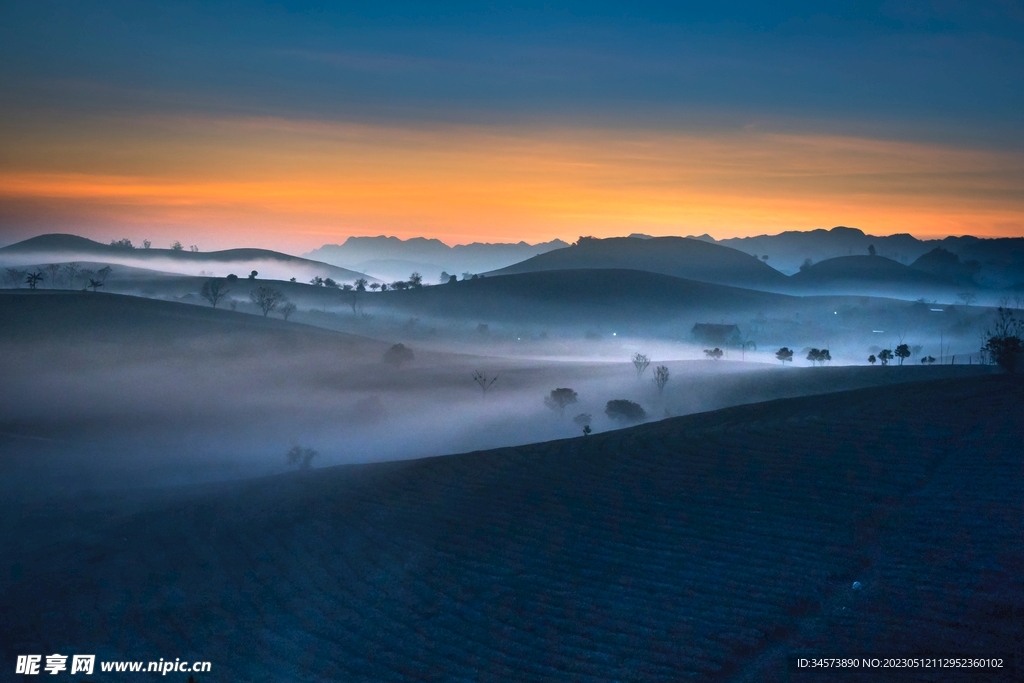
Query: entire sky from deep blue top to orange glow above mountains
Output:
[[0, 0, 1024, 253]]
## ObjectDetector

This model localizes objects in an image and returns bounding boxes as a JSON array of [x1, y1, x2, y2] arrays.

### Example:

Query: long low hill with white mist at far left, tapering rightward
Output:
[[0, 233, 374, 282]]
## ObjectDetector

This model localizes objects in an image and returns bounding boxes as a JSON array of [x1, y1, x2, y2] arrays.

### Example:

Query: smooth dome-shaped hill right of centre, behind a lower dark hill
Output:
[[488, 238, 786, 291]]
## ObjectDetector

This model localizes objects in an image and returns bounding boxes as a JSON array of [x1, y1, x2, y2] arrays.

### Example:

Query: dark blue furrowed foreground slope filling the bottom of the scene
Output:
[[0, 377, 1024, 681]]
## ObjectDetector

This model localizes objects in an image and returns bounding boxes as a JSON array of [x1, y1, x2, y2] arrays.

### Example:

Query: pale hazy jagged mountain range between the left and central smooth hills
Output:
[[305, 236, 568, 283]]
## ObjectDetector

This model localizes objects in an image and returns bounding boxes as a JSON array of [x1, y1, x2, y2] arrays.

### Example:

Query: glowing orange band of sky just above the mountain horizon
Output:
[[0, 114, 1024, 251]]
